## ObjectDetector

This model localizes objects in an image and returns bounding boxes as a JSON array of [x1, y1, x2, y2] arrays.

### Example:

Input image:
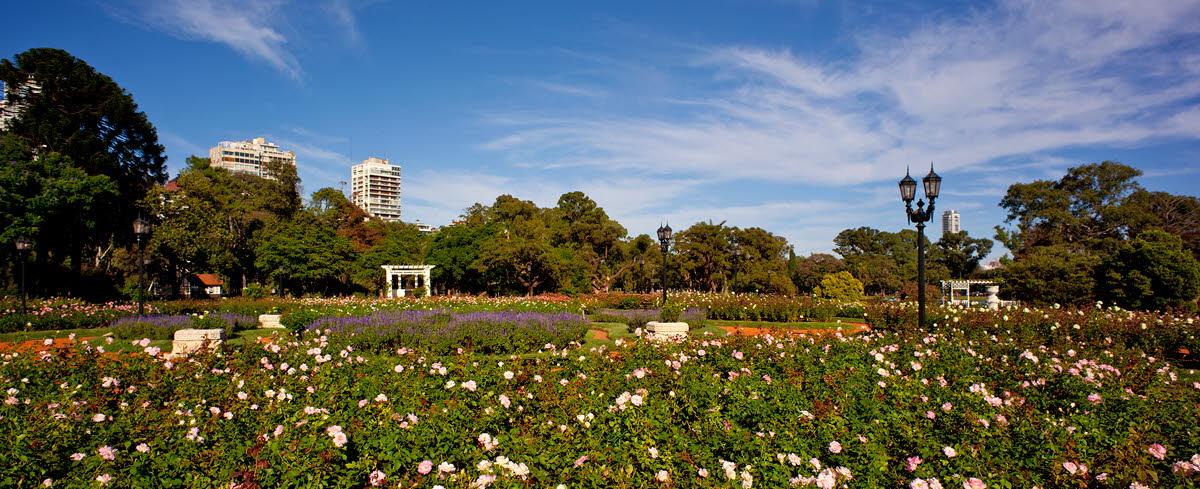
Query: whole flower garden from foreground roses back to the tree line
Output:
[[0, 294, 1200, 488]]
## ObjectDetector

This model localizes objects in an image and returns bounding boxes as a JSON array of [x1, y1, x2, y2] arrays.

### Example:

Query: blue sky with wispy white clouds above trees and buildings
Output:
[[0, 0, 1200, 256]]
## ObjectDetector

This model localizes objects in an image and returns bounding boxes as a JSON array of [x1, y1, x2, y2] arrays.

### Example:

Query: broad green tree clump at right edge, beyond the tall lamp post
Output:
[[996, 162, 1200, 309]]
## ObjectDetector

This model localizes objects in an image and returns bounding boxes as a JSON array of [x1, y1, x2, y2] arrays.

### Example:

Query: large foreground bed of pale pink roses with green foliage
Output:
[[0, 306, 1200, 488]]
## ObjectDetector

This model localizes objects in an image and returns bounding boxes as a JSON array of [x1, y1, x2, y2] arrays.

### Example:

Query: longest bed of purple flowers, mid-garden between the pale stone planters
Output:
[[306, 310, 588, 355]]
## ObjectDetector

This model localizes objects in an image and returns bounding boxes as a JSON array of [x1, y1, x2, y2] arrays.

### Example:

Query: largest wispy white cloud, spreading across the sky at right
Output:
[[486, 0, 1200, 185]]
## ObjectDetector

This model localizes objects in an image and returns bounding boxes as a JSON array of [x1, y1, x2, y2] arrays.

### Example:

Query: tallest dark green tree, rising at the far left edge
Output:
[[0, 48, 167, 295]]
